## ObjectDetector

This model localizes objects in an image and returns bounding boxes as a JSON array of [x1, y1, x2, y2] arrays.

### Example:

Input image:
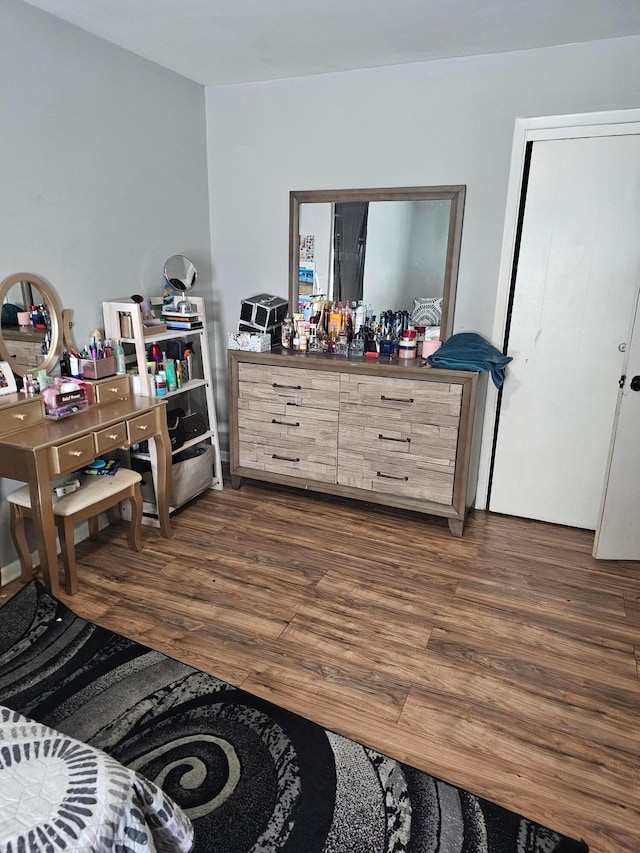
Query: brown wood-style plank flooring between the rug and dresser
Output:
[[0, 483, 640, 853]]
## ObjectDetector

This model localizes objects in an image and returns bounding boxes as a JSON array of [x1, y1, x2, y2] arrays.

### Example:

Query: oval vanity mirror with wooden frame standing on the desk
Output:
[[0, 272, 62, 376]]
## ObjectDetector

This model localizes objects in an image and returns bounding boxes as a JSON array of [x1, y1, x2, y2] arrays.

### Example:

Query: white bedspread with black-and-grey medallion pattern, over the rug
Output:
[[0, 705, 193, 853]]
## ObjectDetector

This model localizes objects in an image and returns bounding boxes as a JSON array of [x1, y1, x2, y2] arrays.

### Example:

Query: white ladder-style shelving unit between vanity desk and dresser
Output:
[[102, 296, 222, 518]]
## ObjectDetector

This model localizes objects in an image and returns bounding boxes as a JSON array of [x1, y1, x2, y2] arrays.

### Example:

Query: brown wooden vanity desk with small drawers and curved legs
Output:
[[0, 390, 172, 595]]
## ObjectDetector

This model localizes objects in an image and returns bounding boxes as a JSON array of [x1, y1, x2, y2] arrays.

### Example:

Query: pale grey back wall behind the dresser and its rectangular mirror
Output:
[[206, 37, 640, 460]]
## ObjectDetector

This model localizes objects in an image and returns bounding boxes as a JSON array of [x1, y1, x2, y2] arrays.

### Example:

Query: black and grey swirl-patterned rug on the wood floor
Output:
[[0, 581, 587, 853]]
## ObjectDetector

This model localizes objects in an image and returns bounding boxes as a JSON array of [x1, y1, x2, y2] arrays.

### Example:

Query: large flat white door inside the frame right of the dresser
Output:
[[489, 134, 640, 530]]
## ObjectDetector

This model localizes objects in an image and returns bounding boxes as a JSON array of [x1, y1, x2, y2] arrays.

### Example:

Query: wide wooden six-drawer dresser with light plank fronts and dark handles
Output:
[[229, 350, 486, 536]]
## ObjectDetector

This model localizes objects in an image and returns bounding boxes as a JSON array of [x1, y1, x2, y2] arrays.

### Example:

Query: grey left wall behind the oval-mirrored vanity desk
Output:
[[0, 0, 211, 565]]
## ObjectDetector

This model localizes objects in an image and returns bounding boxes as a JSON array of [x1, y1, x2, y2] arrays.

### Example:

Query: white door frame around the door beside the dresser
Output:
[[475, 109, 640, 509]]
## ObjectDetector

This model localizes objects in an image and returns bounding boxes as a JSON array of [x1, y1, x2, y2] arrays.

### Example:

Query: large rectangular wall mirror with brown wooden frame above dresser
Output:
[[289, 185, 466, 340]]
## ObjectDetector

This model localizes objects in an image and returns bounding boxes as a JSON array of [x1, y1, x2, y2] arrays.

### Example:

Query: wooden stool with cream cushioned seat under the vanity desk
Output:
[[7, 468, 142, 595]]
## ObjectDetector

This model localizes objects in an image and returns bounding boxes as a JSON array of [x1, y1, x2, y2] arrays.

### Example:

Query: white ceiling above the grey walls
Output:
[[22, 0, 640, 85]]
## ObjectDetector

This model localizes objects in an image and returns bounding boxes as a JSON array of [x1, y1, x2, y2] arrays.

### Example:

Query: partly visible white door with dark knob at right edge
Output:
[[593, 290, 640, 560]]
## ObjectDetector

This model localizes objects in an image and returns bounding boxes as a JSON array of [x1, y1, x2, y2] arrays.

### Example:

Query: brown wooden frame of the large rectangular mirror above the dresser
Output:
[[289, 184, 467, 341]]
